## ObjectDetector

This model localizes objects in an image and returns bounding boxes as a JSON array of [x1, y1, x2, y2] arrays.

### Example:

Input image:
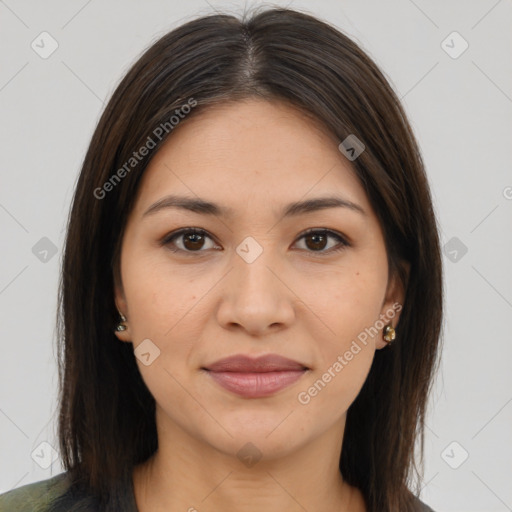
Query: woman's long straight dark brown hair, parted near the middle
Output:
[[57, 8, 443, 512]]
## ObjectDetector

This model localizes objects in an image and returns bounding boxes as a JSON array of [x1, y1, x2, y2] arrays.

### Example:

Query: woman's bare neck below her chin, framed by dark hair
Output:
[[133, 406, 365, 512]]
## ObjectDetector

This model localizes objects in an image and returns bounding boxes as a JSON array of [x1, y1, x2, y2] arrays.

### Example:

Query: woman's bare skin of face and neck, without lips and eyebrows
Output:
[[115, 99, 404, 512]]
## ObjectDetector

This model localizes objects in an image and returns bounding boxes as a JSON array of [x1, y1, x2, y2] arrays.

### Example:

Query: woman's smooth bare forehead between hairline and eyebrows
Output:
[[130, 99, 369, 216]]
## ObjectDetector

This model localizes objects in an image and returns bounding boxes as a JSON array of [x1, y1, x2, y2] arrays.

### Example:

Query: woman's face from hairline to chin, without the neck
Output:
[[115, 100, 403, 459]]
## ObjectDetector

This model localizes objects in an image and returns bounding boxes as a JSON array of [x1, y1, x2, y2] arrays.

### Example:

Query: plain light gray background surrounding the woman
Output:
[[0, 0, 512, 512]]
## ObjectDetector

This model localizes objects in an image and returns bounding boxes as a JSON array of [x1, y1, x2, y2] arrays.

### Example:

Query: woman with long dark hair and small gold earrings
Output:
[[0, 5, 442, 512]]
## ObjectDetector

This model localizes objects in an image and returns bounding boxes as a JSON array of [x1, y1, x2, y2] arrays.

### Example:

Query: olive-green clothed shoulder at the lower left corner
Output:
[[0, 473, 69, 512]]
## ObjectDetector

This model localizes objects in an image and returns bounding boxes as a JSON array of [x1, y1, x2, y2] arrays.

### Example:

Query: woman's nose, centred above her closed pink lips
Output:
[[217, 244, 296, 336]]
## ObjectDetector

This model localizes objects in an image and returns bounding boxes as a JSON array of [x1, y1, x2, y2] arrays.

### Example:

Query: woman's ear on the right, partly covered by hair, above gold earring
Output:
[[375, 261, 411, 350]]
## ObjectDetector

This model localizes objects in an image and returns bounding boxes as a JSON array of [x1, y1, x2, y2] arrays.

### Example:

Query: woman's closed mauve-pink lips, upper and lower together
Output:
[[203, 354, 309, 398]]
